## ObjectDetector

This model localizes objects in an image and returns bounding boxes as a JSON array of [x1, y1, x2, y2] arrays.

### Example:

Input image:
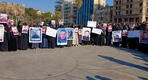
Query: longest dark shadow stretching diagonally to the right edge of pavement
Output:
[[98, 55, 148, 71]]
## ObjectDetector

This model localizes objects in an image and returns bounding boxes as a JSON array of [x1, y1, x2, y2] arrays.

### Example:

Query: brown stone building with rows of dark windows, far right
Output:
[[113, 0, 148, 22]]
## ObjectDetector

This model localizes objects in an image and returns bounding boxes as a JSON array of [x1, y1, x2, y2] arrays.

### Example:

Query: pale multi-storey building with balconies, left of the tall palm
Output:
[[55, 0, 77, 25]]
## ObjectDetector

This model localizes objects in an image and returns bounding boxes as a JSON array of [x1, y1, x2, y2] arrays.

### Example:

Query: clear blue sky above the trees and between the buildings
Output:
[[0, 0, 113, 12]]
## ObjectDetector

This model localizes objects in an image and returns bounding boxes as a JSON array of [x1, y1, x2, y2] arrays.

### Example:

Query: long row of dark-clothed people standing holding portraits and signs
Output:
[[0, 22, 148, 51]]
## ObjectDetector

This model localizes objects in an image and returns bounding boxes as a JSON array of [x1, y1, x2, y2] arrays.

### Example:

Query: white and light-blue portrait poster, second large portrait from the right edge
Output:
[[112, 31, 122, 42]]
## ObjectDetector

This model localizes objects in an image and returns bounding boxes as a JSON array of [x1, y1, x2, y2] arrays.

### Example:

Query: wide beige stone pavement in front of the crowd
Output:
[[0, 46, 148, 80]]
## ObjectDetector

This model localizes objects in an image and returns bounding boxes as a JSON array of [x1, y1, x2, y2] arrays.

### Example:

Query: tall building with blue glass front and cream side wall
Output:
[[78, 0, 106, 25]]
